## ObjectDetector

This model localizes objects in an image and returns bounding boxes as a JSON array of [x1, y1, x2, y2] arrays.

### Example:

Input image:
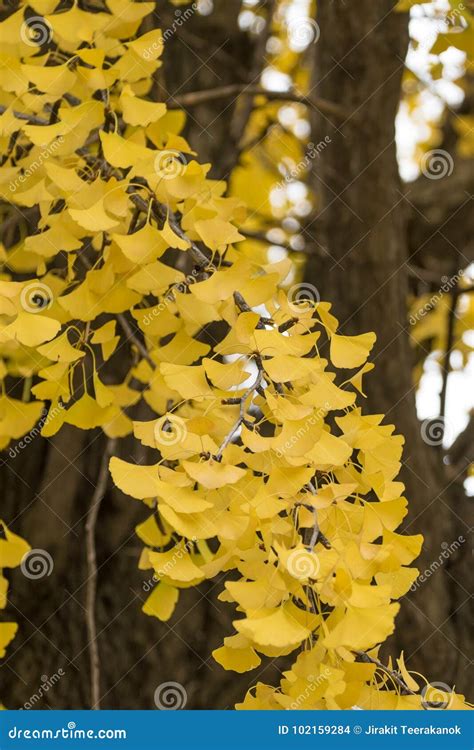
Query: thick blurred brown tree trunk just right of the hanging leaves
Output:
[[306, 0, 471, 688]]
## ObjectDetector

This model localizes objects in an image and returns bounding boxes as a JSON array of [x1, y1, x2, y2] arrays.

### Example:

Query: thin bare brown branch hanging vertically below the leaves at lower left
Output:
[[85, 438, 117, 710]]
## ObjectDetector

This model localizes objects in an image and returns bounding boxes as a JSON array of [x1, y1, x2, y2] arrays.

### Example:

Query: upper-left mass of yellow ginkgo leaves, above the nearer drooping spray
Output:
[[0, 0, 243, 447]]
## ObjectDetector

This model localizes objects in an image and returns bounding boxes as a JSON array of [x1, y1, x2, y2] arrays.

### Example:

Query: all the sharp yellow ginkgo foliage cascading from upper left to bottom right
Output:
[[0, 0, 465, 709]]
